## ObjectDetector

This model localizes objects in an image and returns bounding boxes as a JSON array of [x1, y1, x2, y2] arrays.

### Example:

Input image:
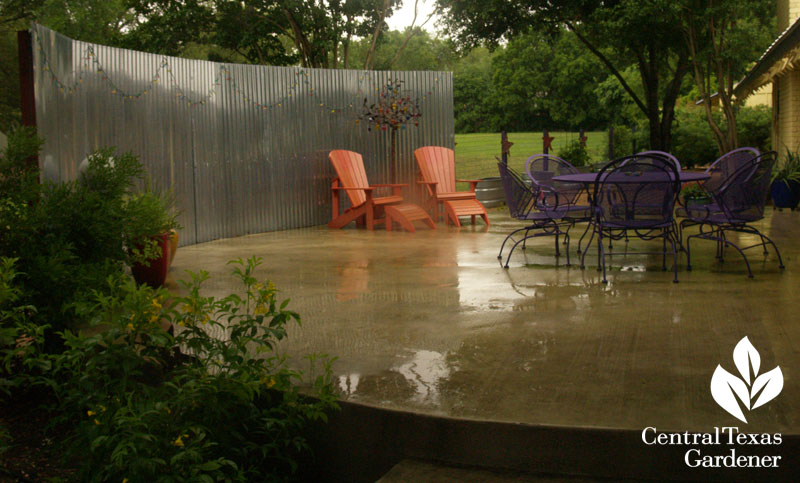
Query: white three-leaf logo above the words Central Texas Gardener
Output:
[[711, 337, 783, 423]]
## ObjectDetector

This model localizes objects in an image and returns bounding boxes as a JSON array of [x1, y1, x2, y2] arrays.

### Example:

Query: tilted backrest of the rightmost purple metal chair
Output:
[[711, 151, 778, 222]]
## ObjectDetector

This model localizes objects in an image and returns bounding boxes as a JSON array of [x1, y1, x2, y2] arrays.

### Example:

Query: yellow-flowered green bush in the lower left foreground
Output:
[[0, 258, 335, 481]]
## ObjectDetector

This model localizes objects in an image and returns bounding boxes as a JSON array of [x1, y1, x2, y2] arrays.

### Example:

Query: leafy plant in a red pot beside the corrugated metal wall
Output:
[[125, 190, 180, 287]]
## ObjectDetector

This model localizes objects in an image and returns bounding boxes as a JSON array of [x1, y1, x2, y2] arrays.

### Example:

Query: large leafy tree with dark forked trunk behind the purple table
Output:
[[438, 0, 773, 150]]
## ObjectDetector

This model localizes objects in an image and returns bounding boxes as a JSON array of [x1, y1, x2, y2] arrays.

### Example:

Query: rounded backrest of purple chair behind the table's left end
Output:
[[525, 154, 583, 208]]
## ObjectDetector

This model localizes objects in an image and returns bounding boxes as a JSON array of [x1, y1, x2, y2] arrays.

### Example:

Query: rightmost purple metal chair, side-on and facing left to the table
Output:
[[686, 151, 784, 278]]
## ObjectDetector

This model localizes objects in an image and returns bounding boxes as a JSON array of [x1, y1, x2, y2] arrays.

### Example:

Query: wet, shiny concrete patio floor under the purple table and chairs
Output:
[[170, 208, 800, 434]]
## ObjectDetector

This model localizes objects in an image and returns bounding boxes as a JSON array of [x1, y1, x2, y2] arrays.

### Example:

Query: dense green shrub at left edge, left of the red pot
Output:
[[0, 128, 180, 340]]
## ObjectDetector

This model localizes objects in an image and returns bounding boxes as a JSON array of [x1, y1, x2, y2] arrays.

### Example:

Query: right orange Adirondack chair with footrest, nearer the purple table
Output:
[[414, 146, 489, 226]]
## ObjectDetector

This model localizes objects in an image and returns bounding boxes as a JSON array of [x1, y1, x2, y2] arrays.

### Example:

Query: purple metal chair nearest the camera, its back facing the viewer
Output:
[[592, 154, 680, 283]]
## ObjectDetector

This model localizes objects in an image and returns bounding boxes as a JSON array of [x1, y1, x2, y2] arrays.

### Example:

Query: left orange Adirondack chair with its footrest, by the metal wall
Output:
[[328, 149, 436, 232]]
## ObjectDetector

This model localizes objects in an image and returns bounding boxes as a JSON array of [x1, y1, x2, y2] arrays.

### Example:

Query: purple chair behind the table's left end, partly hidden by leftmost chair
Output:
[[525, 154, 592, 253]]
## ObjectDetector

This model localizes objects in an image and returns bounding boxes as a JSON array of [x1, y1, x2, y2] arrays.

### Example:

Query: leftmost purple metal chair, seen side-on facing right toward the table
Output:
[[497, 163, 569, 268]]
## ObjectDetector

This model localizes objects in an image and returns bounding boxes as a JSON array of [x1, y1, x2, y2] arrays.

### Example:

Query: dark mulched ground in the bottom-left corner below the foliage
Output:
[[0, 393, 75, 482]]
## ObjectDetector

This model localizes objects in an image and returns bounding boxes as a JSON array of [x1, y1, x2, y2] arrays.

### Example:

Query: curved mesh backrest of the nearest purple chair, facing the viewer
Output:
[[594, 154, 680, 228]]
